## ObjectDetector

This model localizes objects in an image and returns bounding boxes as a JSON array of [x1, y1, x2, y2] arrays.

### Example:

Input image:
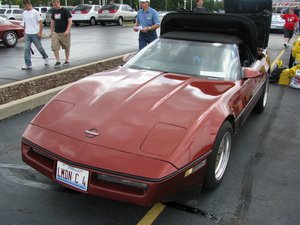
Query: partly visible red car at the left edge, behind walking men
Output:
[[0, 16, 24, 47]]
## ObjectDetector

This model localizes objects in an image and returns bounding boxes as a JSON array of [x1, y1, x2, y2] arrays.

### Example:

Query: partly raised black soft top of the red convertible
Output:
[[160, 12, 258, 57]]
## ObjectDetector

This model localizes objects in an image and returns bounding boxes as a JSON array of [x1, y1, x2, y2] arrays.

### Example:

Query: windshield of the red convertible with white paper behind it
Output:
[[124, 38, 241, 80]]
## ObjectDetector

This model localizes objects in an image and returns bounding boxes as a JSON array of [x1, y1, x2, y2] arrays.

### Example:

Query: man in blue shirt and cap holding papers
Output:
[[133, 0, 160, 50]]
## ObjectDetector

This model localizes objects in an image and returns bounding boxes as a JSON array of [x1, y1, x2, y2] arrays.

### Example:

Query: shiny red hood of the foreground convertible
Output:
[[32, 68, 235, 167]]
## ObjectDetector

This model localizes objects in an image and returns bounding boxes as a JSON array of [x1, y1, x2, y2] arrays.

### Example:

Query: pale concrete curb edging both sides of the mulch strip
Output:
[[0, 55, 124, 120]]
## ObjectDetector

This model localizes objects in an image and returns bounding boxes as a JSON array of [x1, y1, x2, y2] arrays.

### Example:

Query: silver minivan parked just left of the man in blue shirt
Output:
[[98, 4, 137, 26]]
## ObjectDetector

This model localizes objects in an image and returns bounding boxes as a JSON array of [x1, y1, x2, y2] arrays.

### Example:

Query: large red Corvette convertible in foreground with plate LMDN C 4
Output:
[[22, 0, 272, 206]]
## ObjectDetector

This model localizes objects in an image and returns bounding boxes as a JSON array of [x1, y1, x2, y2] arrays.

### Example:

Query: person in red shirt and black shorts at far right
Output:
[[280, 8, 299, 48]]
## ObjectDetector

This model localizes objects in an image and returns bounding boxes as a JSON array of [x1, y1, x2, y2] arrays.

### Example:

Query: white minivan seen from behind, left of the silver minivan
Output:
[[71, 4, 100, 26]]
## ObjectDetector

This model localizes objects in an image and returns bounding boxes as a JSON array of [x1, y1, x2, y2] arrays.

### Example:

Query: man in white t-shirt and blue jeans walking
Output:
[[21, 0, 49, 70]]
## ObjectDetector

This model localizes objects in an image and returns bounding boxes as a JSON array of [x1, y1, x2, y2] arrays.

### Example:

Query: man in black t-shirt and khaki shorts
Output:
[[51, 0, 72, 68]]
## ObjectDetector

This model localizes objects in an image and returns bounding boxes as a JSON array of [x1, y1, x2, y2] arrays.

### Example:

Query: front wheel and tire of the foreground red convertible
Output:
[[203, 121, 233, 190]]
